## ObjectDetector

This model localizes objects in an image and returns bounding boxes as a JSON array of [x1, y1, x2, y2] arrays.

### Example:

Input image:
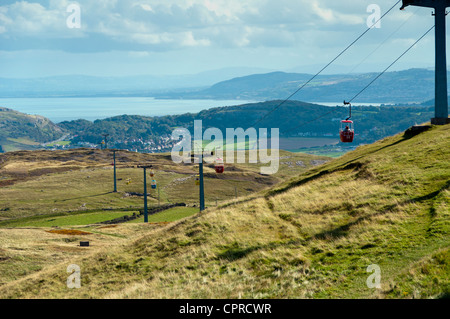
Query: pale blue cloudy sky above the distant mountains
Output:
[[0, 0, 442, 78]]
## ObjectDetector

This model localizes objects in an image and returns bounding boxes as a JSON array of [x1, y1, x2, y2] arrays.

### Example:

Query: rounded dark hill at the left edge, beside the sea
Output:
[[0, 107, 64, 152]]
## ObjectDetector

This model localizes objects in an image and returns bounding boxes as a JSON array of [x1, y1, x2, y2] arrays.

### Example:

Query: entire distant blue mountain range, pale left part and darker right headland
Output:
[[0, 68, 442, 104]]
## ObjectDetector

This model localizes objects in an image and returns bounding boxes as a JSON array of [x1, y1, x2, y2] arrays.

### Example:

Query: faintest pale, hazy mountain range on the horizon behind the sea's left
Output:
[[0, 68, 269, 98]]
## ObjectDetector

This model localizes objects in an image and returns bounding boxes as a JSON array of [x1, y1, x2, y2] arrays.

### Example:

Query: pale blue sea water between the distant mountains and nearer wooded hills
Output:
[[0, 97, 258, 123]]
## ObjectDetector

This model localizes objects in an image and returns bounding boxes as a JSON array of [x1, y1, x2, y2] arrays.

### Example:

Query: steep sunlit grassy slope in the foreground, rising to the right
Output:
[[0, 125, 450, 298]]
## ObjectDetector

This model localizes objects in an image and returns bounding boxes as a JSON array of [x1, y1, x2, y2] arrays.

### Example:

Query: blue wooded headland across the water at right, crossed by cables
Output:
[[158, 69, 434, 104]]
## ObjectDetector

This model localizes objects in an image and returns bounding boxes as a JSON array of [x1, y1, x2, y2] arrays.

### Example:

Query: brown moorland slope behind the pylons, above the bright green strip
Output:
[[0, 149, 330, 221]]
